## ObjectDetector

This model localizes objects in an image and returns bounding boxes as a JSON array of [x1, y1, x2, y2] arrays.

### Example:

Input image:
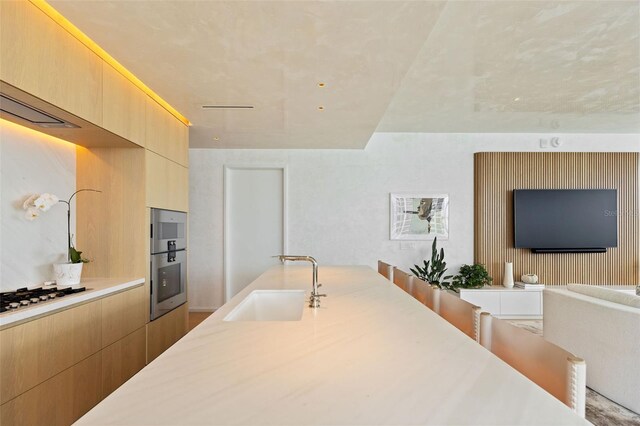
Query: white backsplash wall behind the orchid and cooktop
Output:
[[0, 123, 76, 291]]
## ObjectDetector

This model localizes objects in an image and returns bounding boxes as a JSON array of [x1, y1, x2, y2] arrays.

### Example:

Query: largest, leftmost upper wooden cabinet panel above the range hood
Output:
[[0, 1, 103, 125]]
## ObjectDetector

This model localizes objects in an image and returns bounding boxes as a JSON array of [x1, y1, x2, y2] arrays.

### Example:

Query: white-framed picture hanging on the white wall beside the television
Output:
[[390, 194, 449, 240]]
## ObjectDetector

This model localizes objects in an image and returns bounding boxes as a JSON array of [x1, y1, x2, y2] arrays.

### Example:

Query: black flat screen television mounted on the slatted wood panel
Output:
[[513, 189, 618, 253]]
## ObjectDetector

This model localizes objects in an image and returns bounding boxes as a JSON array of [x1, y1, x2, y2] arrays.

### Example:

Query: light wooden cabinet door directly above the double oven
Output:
[[146, 150, 189, 212]]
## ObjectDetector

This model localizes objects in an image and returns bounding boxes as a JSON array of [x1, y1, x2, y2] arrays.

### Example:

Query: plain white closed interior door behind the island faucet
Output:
[[224, 167, 286, 301]]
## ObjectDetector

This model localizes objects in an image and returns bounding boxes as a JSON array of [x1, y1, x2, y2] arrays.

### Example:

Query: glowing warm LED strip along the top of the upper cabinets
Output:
[[29, 0, 191, 126]]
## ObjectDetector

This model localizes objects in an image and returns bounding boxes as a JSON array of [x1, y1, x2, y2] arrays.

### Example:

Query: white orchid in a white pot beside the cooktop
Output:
[[22, 189, 102, 286]]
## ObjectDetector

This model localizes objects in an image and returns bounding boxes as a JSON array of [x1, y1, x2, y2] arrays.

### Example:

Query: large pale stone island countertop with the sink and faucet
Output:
[[78, 265, 588, 425]]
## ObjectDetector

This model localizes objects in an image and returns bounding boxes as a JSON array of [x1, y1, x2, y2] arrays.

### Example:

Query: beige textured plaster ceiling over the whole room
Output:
[[50, 0, 640, 148]]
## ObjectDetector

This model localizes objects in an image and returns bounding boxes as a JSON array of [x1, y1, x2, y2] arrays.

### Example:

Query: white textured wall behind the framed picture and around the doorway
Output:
[[189, 133, 640, 310]]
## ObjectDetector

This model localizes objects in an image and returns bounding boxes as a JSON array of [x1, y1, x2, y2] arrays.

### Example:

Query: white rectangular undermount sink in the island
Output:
[[223, 290, 305, 321]]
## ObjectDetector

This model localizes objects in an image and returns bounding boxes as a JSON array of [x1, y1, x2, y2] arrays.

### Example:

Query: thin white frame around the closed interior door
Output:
[[222, 164, 289, 303]]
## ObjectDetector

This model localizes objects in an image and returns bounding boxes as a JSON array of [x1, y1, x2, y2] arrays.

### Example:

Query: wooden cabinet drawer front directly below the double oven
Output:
[[147, 303, 189, 363]]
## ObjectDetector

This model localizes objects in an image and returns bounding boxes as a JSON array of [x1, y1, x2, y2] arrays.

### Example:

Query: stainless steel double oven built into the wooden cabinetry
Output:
[[151, 209, 187, 321]]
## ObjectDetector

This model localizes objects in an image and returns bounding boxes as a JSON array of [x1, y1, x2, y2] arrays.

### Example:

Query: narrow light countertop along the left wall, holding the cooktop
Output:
[[0, 278, 144, 330]]
